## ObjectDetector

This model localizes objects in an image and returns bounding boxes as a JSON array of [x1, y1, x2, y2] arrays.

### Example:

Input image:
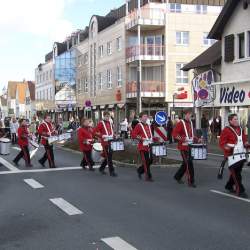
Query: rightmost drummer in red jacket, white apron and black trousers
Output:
[[219, 114, 249, 197]]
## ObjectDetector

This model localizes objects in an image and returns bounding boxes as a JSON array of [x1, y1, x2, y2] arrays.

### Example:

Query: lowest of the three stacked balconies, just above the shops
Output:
[[126, 81, 165, 98]]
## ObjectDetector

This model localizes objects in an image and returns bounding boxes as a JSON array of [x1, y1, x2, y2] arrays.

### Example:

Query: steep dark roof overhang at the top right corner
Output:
[[208, 0, 242, 40]]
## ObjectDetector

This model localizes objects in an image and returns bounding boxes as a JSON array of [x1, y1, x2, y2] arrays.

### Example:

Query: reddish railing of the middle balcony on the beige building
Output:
[[126, 44, 165, 59]]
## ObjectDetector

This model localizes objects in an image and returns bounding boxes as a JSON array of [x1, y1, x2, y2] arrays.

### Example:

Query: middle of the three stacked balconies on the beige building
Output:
[[126, 44, 165, 63]]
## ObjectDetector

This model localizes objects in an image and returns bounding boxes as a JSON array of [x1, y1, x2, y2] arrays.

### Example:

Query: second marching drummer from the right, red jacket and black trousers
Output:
[[173, 110, 200, 188]]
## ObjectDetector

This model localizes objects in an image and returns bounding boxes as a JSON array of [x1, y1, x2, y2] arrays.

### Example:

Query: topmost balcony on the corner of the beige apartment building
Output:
[[126, 8, 165, 30]]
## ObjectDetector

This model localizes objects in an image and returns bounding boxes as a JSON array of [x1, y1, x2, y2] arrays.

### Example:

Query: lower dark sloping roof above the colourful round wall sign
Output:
[[182, 41, 221, 71]]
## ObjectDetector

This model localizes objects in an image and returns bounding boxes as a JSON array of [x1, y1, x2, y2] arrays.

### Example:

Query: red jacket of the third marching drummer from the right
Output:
[[132, 123, 154, 151]]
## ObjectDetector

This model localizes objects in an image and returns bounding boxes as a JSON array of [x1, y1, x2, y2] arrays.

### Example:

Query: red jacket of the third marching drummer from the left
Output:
[[78, 127, 93, 151]]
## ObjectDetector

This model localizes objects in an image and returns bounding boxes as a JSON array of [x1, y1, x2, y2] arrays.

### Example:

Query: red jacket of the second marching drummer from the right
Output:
[[173, 120, 197, 151]]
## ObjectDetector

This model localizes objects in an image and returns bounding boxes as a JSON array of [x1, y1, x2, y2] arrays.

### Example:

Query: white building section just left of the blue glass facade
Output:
[[35, 52, 55, 114]]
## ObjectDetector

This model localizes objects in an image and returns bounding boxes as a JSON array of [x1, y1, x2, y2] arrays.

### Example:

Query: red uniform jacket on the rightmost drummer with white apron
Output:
[[219, 127, 247, 157]]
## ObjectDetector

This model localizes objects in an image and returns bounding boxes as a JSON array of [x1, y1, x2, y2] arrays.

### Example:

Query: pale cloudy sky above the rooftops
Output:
[[0, 0, 125, 90]]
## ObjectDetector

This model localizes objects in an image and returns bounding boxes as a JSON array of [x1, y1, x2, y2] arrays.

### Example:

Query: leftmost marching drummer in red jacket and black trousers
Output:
[[13, 119, 32, 167]]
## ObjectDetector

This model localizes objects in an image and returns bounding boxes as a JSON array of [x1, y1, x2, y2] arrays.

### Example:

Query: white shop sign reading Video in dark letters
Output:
[[215, 83, 250, 106]]
